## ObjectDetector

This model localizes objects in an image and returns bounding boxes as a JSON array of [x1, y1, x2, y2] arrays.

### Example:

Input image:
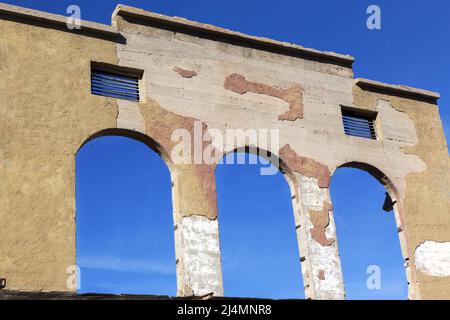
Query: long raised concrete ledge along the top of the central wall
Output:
[[112, 4, 355, 68]]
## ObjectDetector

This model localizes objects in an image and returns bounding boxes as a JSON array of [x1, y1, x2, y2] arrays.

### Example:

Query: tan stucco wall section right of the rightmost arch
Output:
[[353, 85, 450, 299]]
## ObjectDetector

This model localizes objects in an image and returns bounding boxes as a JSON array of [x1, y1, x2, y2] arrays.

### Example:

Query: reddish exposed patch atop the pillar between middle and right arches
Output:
[[280, 144, 331, 188]]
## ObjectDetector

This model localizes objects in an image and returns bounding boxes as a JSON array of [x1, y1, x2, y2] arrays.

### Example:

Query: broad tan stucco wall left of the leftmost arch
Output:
[[0, 19, 117, 291]]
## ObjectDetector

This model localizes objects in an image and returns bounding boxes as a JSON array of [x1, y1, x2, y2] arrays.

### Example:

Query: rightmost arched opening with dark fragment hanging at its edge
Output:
[[331, 167, 408, 300]]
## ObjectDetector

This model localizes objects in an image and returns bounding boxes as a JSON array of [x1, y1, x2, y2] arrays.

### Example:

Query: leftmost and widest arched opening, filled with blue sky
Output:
[[76, 136, 176, 296]]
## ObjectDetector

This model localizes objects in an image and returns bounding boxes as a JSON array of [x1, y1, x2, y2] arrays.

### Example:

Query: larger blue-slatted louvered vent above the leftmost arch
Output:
[[91, 69, 139, 101]]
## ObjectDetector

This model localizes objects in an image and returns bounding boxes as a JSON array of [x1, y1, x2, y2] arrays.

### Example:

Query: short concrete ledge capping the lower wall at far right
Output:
[[355, 78, 440, 102]]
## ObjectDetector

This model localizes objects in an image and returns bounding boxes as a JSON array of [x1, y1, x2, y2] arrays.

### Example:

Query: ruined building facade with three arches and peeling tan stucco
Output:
[[0, 5, 450, 299]]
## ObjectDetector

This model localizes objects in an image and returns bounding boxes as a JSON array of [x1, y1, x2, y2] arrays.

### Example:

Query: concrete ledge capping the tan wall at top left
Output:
[[0, 3, 119, 37]]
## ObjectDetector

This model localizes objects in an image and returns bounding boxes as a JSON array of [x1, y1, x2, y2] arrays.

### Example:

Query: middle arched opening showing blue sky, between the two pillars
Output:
[[216, 153, 304, 299]]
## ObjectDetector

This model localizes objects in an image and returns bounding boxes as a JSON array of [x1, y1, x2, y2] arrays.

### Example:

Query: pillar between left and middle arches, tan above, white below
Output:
[[172, 165, 223, 297]]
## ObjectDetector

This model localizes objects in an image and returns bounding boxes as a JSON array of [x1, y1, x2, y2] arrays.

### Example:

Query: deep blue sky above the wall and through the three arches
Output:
[[3, 0, 450, 299]]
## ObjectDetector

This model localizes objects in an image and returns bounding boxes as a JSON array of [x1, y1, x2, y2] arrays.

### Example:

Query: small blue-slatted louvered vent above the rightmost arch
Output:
[[342, 109, 377, 140]]
